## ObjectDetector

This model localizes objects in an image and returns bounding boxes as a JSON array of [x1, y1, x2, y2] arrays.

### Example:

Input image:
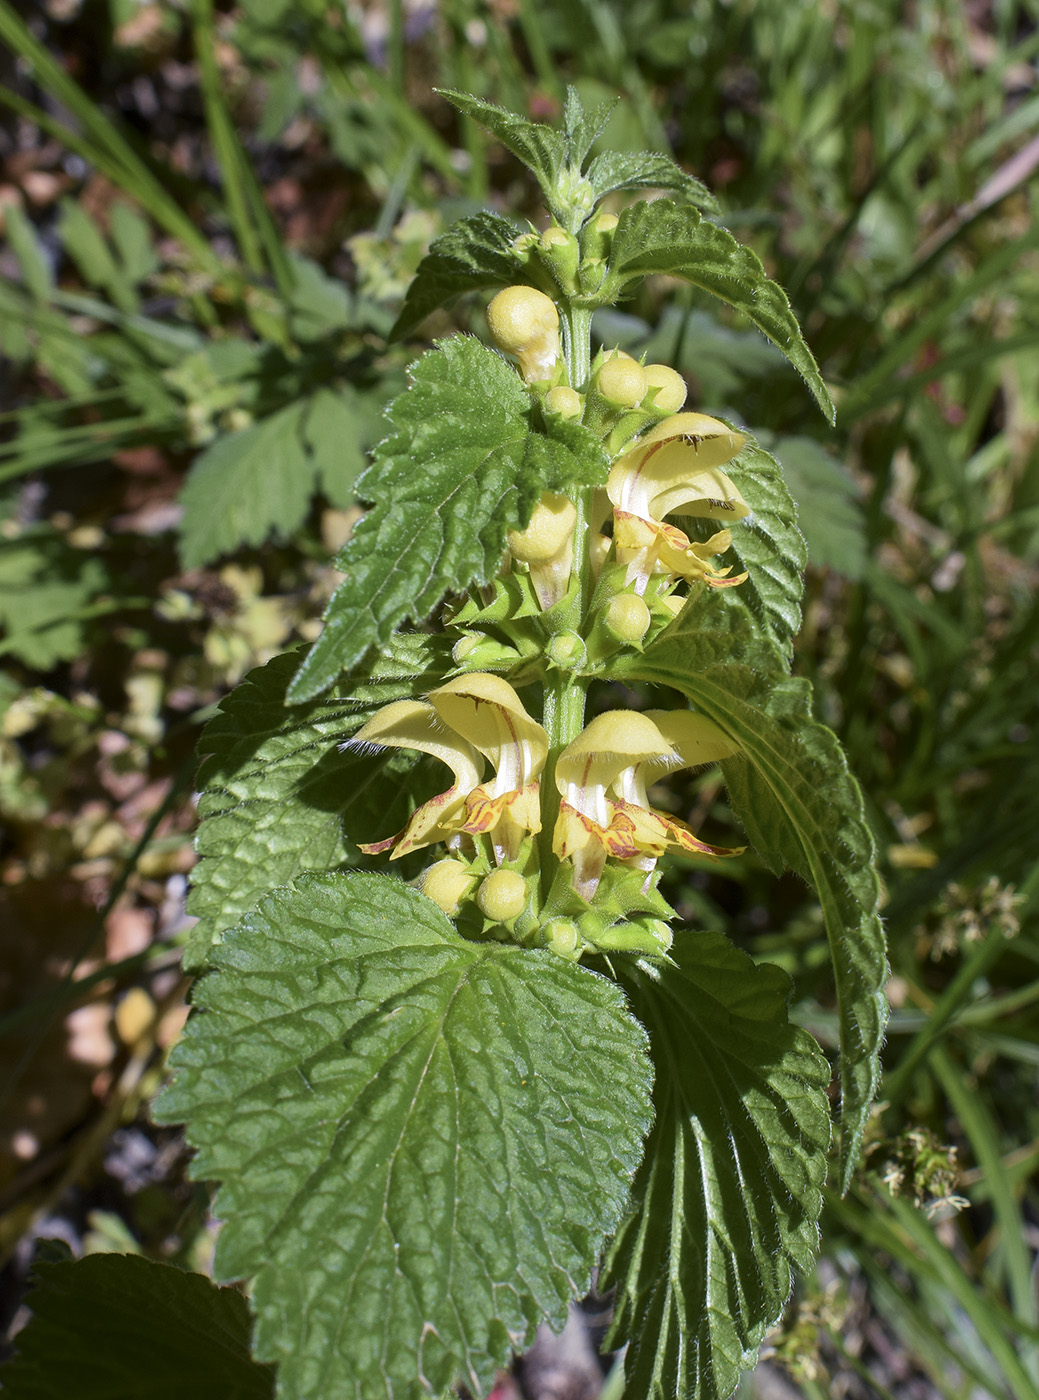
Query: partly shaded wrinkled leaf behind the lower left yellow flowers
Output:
[[183, 636, 451, 972]]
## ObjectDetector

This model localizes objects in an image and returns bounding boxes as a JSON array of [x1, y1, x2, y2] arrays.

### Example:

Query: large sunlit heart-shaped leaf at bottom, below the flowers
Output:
[[158, 875, 651, 1400]]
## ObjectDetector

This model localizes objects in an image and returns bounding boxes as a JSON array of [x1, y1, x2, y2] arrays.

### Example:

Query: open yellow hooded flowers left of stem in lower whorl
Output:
[[350, 672, 548, 860]]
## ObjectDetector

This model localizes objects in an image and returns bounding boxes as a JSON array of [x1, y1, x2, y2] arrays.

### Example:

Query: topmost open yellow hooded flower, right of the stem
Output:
[[606, 413, 751, 594]]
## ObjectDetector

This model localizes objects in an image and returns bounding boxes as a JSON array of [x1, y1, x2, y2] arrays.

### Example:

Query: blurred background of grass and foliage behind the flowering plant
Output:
[[0, 0, 1039, 1400]]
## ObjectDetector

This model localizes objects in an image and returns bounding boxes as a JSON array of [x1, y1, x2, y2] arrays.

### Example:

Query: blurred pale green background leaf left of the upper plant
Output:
[[181, 399, 314, 568]]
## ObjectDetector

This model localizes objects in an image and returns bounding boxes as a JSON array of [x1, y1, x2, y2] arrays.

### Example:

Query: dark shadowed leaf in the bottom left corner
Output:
[[0, 1254, 274, 1400]]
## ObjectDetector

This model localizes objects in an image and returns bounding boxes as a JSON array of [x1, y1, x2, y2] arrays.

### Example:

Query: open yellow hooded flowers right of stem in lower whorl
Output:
[[552, 710, 738, 899]]
